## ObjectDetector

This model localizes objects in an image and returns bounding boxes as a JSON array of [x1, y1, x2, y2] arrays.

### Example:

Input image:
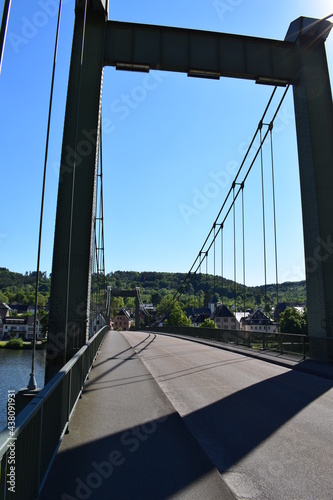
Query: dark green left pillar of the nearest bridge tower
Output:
[[45, 1, 107, 382]]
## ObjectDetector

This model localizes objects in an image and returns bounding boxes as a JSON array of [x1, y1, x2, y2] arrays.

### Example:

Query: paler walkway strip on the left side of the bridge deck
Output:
[[40, 332, 234, 500]]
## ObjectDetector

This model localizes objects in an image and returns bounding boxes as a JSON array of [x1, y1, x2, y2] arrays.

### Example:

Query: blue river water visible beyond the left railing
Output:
[[0, 349, 46, 430]]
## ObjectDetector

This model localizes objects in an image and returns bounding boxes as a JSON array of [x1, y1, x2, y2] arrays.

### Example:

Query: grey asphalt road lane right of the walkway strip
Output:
[[122, 331, 333, 500]]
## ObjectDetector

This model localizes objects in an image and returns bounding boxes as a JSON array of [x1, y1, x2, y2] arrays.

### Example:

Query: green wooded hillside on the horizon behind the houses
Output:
[[0, 268, 306, 310]]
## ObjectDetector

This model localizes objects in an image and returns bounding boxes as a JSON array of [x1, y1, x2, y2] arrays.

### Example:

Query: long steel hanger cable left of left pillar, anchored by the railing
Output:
[[28, 0, 62, 390]]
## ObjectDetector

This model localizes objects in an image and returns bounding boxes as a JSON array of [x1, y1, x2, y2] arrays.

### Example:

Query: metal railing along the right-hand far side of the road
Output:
[[150, 326, 309, 359]]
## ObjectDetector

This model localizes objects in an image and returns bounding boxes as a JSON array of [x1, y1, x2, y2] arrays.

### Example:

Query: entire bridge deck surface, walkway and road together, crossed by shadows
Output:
[[41, 331, 333, 500]]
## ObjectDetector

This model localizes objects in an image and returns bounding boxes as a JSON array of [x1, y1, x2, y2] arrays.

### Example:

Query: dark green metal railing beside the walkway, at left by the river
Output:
[[0, 326, 109, 500]]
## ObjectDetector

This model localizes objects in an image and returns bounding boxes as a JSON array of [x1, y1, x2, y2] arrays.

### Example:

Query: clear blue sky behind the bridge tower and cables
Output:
[[0, 0, 333, 285]]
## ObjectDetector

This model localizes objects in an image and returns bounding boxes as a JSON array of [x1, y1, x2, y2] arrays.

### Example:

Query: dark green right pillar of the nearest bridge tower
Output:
[[290, 20, 333, 359]]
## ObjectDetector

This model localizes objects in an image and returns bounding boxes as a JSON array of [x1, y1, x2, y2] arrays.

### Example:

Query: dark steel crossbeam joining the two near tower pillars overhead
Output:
[[104, 21, 297, 85]]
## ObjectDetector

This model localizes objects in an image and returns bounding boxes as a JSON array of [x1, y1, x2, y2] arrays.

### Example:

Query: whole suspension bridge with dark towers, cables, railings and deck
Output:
[[0, 0, 333, 499]]
